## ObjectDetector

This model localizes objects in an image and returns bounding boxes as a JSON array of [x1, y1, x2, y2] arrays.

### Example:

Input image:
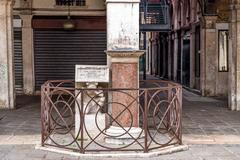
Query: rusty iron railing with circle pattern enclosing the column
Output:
[[41, 80, 182, 153]]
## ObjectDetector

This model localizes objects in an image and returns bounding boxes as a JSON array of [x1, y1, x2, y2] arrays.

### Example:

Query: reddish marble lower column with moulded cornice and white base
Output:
[[105, 50, 144, 145]]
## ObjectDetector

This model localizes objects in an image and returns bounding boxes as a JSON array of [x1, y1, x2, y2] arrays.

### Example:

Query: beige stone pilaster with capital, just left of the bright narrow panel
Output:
[[200, 16, 218, 96]]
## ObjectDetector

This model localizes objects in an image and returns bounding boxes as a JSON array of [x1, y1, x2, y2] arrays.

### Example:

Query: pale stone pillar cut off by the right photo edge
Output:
[[228, 0, 240, 111]]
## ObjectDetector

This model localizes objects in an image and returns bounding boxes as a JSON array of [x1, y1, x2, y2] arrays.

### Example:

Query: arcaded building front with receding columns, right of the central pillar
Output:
[[146, 0, 239, 110]]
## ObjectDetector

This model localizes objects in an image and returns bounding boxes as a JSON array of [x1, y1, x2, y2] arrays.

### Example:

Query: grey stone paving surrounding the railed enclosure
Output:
[[0, 91, 240, 160]]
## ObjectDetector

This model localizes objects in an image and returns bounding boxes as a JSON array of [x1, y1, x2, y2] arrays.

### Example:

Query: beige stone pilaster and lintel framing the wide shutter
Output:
[[13, 0, 106, 94]]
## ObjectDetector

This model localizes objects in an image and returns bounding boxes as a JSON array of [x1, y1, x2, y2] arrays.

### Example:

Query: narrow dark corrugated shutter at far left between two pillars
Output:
[[14, 28, 23, 93]]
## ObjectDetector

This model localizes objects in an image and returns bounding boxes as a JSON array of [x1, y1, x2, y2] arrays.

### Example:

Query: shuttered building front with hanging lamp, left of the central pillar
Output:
[[13, 0, 107, 94]]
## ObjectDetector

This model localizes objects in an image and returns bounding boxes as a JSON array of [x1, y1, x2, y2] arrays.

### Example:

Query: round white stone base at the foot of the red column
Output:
[[105, 126, 144, 145]]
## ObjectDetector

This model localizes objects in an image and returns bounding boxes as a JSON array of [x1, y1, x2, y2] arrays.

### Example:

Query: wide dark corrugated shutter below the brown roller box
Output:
[[34, 30, 106, 90]]
